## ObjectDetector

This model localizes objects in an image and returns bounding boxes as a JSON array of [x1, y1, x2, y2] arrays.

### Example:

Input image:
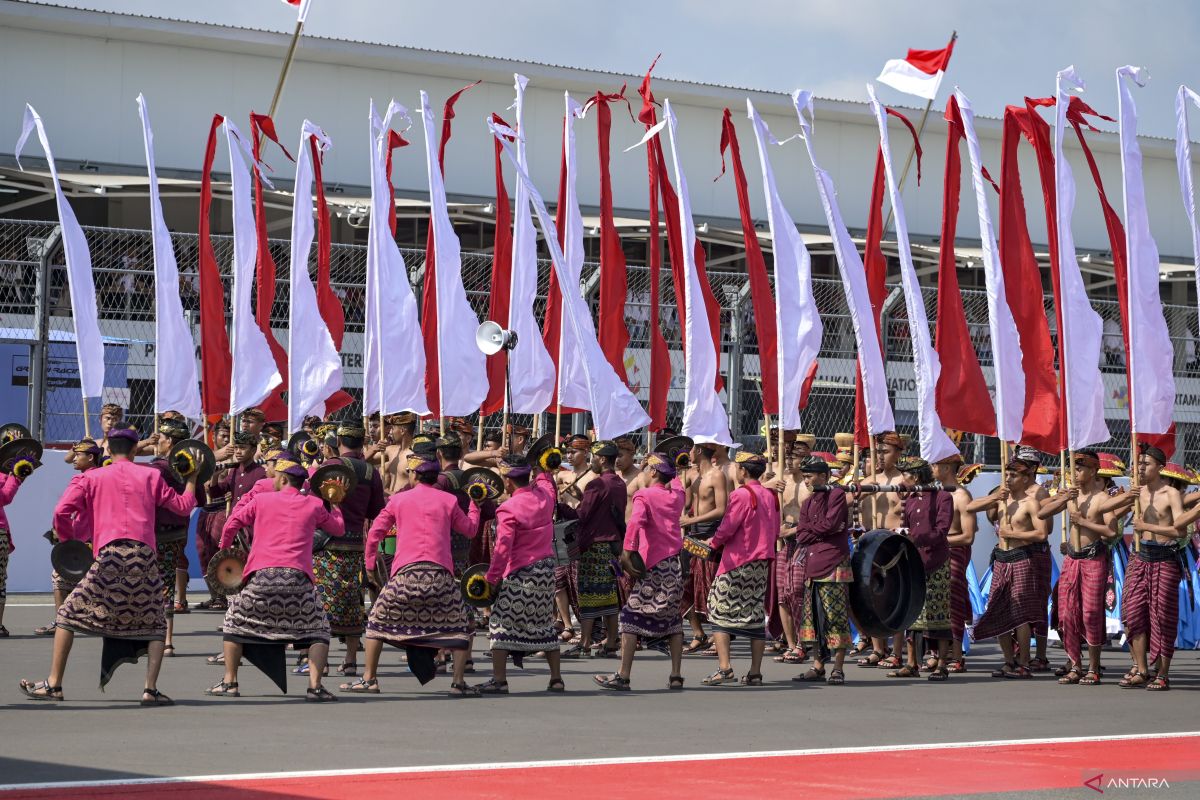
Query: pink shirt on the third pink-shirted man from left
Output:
[[365, 483, 479, 577]]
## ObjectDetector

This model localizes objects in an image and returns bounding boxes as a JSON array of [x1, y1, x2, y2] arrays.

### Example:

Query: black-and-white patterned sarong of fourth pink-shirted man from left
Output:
[[487, 558, 558, 652]]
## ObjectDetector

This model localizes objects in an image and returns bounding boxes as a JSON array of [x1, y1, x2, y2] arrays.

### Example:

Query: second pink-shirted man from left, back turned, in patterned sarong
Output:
[[204, 452, 346, 703]]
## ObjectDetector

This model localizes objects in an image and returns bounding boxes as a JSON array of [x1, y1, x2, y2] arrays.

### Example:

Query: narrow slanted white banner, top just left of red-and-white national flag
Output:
[[866, 84, 959, 464]]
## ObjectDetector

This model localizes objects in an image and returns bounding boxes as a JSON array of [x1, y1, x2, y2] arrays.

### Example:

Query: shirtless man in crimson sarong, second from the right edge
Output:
[[1038, 450, 1114, 686]]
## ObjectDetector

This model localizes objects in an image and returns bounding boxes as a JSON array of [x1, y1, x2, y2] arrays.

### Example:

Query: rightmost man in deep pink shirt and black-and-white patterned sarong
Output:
[[703, 451, 779, 686]]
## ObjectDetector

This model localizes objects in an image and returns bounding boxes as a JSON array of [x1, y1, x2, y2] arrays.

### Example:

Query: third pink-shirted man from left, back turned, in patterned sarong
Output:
[[341, 456, 479, 697]]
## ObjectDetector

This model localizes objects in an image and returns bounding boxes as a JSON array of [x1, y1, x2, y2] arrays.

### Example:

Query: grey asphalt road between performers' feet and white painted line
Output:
[[0, 596, 1200, 796]]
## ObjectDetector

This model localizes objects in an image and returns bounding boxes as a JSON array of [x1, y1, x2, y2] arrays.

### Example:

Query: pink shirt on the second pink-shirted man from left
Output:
[[221, 486, 346, 583]]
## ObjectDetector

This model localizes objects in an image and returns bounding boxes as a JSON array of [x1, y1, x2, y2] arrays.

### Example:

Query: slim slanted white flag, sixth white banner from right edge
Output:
[[792, 90, 895, 437]]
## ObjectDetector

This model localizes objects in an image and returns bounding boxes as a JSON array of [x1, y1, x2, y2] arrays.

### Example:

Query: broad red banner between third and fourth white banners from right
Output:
[[1000, 98, 1063, 452]]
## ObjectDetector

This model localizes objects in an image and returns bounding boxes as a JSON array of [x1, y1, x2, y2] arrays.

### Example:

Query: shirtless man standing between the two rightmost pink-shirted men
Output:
[[679, 443, 733, 652]]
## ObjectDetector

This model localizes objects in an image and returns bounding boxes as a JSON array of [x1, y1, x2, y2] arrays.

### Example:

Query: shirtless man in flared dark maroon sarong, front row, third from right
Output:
[[967, 445, 1050, 678]]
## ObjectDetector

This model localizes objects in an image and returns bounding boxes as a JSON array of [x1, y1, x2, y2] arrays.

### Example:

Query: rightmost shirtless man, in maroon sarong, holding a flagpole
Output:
[[1099, 445, 1185, 692]]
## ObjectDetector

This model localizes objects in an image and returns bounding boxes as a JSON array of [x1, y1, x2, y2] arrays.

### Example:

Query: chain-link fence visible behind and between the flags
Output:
[[0, 219, 1200, 464]]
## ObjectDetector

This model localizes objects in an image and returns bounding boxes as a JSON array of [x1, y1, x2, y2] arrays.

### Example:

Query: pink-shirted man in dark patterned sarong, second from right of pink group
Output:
[[594, 453, 684, 691]]
